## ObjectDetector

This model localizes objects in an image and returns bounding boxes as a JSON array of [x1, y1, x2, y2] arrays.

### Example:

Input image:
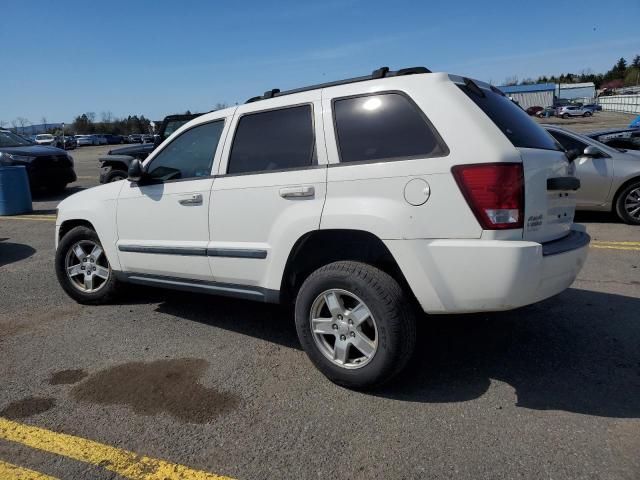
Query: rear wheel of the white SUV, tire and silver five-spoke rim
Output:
[[295, 261, 416, 390]]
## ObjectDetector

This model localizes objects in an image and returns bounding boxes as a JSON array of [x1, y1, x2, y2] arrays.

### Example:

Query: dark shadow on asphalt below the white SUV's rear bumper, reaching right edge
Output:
[[377, 289, 640, 418]]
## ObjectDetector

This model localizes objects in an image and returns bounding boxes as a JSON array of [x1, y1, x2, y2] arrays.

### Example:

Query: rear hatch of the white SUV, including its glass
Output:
[[456, 79, 576, 243]]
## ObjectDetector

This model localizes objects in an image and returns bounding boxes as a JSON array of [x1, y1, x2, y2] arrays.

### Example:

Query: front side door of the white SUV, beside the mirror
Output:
[[117, 115, 232, 283]]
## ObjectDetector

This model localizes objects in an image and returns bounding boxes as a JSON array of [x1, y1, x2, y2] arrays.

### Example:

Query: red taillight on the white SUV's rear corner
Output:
[[451, 163, 524, 230]]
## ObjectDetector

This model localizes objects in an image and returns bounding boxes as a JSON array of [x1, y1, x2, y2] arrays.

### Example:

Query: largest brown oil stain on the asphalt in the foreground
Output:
[[71, 358, 239, 423]]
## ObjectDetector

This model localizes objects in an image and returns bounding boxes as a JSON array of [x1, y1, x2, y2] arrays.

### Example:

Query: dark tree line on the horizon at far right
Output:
[[505, 55, 640, 89]]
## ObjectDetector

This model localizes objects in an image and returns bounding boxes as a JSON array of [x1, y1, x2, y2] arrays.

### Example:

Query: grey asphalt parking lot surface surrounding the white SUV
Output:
[[0, 136, 640, 479]]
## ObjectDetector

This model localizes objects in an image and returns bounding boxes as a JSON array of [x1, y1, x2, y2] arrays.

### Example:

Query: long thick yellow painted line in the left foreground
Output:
[[0, 417, 231, 480]]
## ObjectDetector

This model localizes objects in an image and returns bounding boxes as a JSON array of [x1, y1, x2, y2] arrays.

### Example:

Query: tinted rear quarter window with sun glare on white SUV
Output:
[[333, 93, 448, 163]]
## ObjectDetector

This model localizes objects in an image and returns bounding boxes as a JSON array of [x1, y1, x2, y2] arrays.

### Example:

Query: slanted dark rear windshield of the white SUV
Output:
[[458, 81, 559, 150]]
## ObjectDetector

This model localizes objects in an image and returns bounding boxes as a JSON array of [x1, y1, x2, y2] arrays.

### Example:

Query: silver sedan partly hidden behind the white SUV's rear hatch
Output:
[[545, 125, 640, 225]]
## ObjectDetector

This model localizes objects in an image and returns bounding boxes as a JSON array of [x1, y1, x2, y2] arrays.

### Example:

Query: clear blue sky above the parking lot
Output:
[[0, 0, 640, 124]]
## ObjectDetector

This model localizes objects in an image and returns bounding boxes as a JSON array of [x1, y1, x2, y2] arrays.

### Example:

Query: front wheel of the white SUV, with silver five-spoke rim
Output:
[[55, 227, 118, 305]]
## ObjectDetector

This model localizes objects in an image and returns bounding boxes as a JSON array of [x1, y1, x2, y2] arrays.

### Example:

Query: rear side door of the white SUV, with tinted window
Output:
[[209, 90, 327, 298]]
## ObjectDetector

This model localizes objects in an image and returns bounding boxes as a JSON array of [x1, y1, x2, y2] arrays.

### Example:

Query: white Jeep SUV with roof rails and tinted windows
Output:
[[56, 67, 589, 388]]
